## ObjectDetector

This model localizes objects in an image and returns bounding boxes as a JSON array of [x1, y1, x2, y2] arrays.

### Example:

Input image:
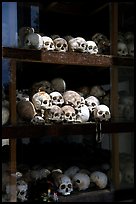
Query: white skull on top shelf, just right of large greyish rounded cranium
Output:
[[42, 36, 55, 51]]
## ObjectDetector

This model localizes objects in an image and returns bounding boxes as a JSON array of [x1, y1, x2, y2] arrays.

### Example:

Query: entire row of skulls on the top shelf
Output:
[[19, 27, 134, 56]]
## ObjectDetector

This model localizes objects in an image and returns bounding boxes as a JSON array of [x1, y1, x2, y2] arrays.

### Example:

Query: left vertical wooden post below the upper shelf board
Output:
[[9, 60, 16, 202]]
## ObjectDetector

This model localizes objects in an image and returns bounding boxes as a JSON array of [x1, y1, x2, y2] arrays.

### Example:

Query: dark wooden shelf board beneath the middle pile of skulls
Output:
[[2, 122, 134, 139]]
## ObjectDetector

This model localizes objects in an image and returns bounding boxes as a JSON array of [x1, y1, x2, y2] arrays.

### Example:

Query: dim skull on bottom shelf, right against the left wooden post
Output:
[[17, 180, 28, 202]]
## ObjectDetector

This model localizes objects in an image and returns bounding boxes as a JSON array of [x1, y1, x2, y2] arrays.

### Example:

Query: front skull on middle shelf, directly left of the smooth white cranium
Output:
[[62, 105, 76, 122]]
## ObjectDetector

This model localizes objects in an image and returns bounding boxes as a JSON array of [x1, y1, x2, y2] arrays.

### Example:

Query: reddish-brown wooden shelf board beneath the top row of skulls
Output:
[[2, 47, 134, 67]]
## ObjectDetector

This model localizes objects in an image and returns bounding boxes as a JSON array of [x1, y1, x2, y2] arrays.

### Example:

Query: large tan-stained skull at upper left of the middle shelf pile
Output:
[[32, 91, 52, 117]]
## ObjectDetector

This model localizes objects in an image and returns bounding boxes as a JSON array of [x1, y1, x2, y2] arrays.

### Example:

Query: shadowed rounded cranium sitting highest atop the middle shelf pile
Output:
[[51, 78, 66, 93]]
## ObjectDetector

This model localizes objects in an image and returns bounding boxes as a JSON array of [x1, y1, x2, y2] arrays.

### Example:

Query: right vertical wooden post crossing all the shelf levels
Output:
[[110, 2, 120, 190]]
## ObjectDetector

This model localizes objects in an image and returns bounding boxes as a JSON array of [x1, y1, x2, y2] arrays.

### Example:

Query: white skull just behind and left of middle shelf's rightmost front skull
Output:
[[85, 96, 100, 113]]
